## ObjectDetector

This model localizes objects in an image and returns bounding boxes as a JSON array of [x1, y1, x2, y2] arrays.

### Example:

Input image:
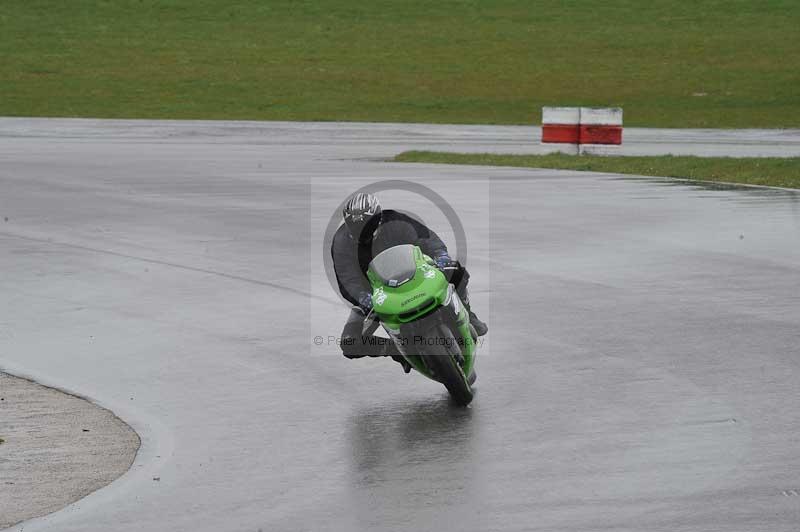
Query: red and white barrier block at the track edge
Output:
[[542, 107, 622, 154]]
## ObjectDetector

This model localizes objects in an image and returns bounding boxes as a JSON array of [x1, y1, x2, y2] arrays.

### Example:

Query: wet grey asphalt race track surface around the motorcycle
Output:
[[0, 120, 800, 531]]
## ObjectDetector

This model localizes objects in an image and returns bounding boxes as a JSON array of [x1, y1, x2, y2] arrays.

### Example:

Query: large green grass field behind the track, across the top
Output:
[[0, 0, 800, 127]]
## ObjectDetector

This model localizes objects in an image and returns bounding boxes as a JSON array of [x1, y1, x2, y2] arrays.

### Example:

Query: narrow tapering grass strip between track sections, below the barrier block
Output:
[[394, 151, 800, 188]]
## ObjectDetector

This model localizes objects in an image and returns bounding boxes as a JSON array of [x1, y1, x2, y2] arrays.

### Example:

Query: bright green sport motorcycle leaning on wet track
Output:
[[364, 244, 478, 406]]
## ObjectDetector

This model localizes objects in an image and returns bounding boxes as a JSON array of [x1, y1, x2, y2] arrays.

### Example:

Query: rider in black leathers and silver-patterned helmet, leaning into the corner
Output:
[[331, 192, 488, 373]]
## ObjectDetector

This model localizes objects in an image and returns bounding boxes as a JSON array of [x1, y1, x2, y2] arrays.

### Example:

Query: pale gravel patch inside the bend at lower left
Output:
[[0, 373, 139, 528]]
